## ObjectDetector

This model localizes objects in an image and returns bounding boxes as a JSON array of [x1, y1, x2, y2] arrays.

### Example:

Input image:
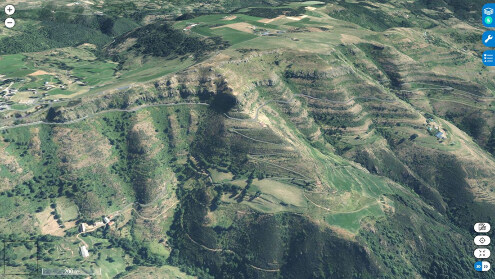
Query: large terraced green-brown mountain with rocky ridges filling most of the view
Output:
[[0, 1, 495, 278]]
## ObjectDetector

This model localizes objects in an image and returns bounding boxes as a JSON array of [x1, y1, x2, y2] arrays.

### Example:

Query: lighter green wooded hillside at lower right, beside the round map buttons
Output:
[[357, 195, 475, 279]]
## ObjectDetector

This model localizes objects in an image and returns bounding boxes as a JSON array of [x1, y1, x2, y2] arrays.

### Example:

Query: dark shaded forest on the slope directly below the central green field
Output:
[[169, 178, 378, 279]]
